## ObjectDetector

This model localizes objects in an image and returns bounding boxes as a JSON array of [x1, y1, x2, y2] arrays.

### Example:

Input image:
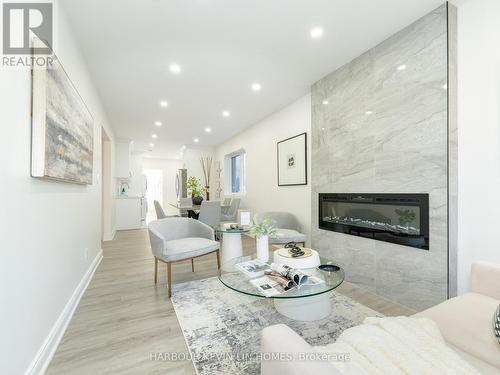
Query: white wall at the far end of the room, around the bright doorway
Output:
[[142, 158, 182, 215]]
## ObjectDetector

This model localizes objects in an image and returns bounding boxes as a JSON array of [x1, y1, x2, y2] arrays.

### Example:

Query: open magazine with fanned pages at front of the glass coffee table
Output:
[[245, 263, 324, 297]]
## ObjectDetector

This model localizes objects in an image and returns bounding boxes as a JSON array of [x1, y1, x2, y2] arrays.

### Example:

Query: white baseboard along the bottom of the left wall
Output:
[[25, 249, 102, 375]]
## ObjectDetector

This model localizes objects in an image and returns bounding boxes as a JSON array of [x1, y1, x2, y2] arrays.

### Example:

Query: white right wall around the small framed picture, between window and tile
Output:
[[215, 94, 311, 241]]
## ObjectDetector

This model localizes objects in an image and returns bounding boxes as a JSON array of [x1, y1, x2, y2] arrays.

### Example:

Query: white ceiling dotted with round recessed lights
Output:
[[62, 0, 444, 158]]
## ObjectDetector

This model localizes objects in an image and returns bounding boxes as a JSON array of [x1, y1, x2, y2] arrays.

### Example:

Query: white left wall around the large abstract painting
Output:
[[0, 4, 114, 374]]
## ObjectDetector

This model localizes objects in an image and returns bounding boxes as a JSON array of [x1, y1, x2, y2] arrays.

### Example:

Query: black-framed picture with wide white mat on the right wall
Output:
[[278, 133, 307, 186]]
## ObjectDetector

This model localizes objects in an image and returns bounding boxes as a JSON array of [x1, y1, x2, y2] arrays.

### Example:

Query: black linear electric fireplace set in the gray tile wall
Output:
[[319, 193, 429, 250]]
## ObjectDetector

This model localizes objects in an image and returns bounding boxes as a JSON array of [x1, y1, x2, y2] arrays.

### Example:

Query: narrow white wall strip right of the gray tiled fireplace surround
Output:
[[458, 0, 500, 294]]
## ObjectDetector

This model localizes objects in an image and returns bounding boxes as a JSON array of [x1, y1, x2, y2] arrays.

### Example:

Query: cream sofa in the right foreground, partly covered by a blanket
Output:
[[261, 262, 500, 375]]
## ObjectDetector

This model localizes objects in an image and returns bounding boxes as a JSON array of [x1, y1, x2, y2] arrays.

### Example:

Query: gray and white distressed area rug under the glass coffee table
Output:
[[172, 277, 381, 375]]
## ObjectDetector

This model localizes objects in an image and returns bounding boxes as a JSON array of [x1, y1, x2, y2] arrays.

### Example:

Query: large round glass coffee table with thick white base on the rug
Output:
[[219, 252, 345, 321]]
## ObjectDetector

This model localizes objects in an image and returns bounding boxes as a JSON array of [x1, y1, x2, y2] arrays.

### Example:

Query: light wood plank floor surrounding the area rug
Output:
[[47, 230, 414, 375]]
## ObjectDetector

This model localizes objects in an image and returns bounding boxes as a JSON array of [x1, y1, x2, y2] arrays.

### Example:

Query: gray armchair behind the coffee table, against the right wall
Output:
[[254, 212, 307, 246]]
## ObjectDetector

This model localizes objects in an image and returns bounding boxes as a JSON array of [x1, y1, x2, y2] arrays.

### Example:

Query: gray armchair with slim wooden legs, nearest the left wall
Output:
[[149, 217, 220, 298]]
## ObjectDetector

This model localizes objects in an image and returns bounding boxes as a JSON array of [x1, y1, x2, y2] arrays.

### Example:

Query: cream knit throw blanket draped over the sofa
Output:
[[316, 317, 479, 375]]
